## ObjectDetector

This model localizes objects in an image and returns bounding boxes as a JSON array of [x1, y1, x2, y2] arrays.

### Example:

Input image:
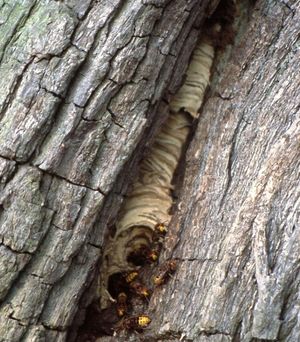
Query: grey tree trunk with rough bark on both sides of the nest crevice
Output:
[[0, 0, 300, 342]]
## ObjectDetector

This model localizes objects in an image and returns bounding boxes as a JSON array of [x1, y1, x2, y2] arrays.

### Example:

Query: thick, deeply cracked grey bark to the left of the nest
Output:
[[0, 0, 216, 342]]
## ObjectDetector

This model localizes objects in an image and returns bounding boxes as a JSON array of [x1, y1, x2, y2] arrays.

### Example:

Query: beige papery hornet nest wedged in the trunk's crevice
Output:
[[99, 32, 214, 309]]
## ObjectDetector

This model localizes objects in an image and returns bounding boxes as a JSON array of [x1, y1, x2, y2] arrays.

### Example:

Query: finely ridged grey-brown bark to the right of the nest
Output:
[[145, 1, 300, 341]]
